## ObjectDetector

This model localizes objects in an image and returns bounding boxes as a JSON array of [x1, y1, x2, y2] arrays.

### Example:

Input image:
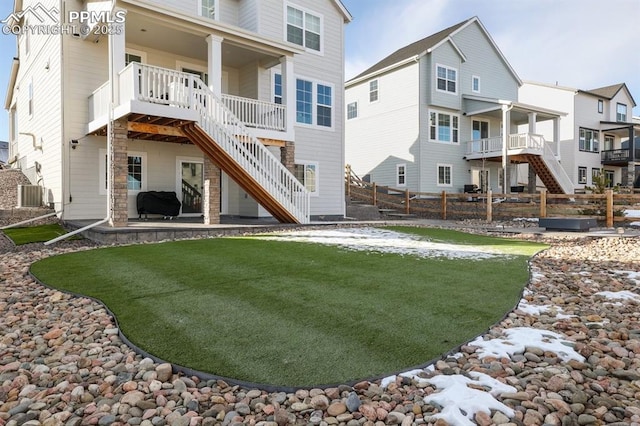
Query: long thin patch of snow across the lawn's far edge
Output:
[[252, 228, 507, 260]]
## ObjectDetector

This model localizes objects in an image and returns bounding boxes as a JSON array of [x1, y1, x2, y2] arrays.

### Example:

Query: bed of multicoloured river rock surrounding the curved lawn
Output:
[[0, 231, 640, 426]]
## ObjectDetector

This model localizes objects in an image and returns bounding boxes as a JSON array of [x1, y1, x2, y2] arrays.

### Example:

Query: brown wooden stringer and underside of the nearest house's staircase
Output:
[[182, 123, 300, 223]]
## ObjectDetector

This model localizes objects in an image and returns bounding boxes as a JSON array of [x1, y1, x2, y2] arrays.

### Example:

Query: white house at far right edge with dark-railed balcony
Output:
[[519, 82, 640, 189]]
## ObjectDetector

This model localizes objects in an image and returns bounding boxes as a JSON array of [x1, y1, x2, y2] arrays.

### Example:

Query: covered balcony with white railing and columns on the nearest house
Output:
[[87, 1, 300, 145]]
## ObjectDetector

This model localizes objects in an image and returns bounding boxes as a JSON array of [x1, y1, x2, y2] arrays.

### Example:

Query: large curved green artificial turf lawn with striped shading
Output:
[[31, 228, 545, 386]]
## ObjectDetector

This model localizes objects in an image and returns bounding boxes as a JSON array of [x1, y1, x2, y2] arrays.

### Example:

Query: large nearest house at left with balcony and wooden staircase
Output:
[[5, 0, 351, 226]]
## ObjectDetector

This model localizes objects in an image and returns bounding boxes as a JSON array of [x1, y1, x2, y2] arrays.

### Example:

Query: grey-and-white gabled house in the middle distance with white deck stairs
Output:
[[345, 17, 573, 193]]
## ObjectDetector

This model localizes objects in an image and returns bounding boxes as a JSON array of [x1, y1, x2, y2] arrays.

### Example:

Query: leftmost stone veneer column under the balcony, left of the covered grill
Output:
[[107, 117, 129, 227]]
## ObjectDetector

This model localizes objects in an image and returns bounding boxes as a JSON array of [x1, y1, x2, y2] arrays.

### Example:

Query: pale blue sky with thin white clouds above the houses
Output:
[[0, 0, 640, 140]]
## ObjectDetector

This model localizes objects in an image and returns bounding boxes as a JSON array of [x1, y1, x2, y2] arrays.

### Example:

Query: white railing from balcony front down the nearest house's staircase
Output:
[[127, 63, 310, 223]]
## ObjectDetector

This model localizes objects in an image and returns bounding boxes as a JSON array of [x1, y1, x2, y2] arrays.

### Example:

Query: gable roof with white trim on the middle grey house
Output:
[[347, 16, 522, 84]]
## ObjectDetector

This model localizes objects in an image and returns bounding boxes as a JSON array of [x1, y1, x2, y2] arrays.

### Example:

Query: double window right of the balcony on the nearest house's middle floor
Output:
[[296, 79, 333, 127]]
